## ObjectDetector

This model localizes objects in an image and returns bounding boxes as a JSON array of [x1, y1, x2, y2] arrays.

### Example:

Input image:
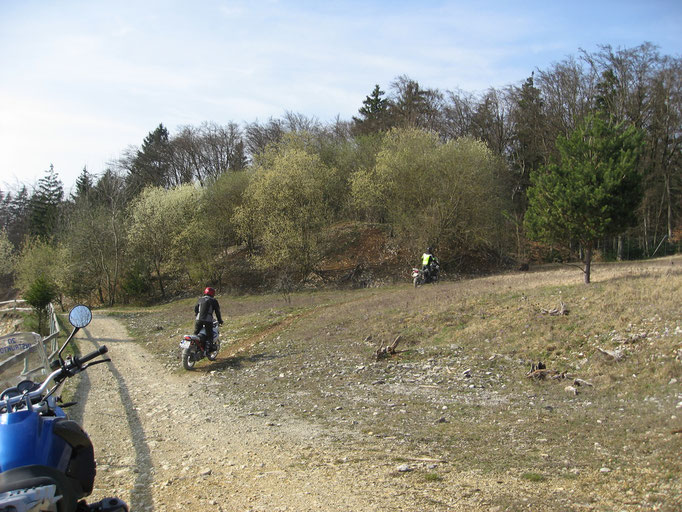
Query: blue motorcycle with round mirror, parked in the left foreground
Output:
[[0, 305, 128, 512]]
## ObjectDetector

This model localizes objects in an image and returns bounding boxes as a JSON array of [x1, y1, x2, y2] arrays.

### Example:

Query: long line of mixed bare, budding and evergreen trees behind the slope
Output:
[[0, 43, 682, 304]]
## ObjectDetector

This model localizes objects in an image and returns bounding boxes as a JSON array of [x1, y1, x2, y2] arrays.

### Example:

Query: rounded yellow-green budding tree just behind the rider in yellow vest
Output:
[[352, 128, 500, 262]]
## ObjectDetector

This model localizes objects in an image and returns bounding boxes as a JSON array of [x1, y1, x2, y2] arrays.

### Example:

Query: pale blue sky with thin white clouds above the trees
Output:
[[0, 0, 682, 190]]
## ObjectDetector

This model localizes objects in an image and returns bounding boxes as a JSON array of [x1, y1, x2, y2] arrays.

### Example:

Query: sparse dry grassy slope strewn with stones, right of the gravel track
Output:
[[111, 257, 682, 511]]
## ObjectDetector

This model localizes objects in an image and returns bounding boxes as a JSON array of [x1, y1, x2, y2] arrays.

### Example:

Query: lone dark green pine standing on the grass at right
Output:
[[525, 116, 643, 283]]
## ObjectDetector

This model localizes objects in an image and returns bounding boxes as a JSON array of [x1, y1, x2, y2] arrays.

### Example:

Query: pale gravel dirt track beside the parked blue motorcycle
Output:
[[71, 315, 436, 512]]
